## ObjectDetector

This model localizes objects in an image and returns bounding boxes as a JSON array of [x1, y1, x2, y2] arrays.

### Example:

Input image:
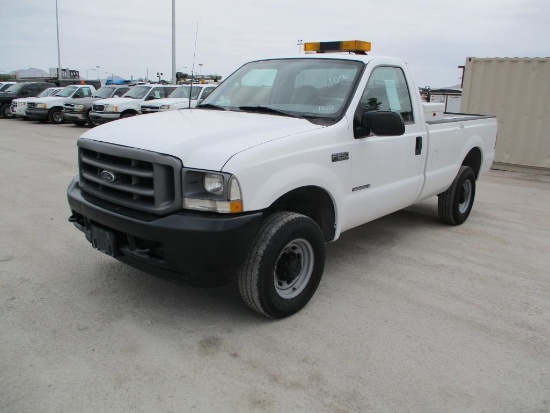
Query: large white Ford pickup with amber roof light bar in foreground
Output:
[[68, 41, 497, 318]]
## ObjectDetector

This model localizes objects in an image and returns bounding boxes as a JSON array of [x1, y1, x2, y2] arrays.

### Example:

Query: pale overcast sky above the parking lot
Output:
[[0, 0, 550, 88]]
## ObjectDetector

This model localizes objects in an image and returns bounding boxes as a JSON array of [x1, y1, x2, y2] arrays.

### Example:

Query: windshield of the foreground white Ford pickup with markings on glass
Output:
[[199, 58, 364, 120]]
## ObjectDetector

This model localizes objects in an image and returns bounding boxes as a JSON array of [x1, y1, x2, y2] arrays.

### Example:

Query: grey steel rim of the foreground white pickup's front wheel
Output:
[[273, 238, 315, 300]]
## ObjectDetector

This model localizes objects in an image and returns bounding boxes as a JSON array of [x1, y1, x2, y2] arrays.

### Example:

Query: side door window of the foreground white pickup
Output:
[[359, 66, 414, 123]]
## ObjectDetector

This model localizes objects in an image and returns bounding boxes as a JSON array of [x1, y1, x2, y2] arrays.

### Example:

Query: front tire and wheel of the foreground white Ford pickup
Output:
[[238, 212, 325, 318]]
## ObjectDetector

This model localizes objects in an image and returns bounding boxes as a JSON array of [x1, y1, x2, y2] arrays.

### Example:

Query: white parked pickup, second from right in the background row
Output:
[[90, 85, 177, 124]]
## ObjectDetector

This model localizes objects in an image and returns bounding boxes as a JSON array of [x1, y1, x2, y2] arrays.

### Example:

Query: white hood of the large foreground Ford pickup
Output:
[[82, 109, 323, 171]]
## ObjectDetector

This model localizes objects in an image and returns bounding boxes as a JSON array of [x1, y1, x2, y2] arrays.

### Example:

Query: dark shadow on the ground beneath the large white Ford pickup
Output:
[[88, 200, 446, 328]]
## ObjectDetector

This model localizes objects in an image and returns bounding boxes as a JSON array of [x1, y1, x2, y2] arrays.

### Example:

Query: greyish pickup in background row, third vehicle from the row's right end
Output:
[[63, 85, 130, 126]]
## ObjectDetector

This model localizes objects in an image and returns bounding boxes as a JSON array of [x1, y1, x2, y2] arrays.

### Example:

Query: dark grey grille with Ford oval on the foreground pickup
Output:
[[78, 139, 182, 215]]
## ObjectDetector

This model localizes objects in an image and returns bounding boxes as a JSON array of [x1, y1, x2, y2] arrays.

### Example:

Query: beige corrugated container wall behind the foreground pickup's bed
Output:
[[460, 57, 550, 169]]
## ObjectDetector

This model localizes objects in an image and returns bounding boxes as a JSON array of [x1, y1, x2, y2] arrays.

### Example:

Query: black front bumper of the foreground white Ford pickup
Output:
[[67, 176, 262, 286]]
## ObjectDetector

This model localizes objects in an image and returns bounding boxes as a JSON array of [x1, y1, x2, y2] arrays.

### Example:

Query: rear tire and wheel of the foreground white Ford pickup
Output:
[[437, 165, 476, 225]]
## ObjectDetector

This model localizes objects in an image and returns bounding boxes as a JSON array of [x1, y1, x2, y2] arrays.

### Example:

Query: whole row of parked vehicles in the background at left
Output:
[[0, 82, 217, 126]]
